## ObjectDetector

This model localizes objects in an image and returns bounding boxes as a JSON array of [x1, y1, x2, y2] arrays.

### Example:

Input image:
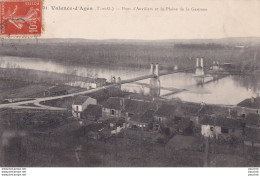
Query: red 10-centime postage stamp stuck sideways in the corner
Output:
[[0, 0, 43, 36]]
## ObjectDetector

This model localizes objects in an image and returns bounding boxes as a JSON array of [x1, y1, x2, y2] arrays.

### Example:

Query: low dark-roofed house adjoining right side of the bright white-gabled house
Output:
[[83, 104, 102, 121]]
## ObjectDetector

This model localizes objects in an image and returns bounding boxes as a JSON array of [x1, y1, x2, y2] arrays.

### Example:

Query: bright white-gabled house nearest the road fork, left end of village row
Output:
[[72, 95, 97, 118]]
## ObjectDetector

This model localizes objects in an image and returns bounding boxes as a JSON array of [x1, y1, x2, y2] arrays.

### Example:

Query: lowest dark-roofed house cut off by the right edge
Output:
[[244, 128, 260, 147]]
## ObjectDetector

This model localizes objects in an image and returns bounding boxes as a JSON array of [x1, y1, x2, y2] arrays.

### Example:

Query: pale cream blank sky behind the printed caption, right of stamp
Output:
[[42, 0, 260, 40]]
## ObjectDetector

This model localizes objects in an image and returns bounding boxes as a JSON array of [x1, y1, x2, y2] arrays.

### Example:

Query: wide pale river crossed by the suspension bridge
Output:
[[0, 56, 260, 105]]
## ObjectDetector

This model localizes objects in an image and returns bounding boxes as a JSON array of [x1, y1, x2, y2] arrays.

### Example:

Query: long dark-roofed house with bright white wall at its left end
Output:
[[200, 116, 244, 138]]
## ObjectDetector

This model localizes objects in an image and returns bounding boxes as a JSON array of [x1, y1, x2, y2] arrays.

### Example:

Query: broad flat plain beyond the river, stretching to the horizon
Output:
[[0, 39, 260, 70]]
